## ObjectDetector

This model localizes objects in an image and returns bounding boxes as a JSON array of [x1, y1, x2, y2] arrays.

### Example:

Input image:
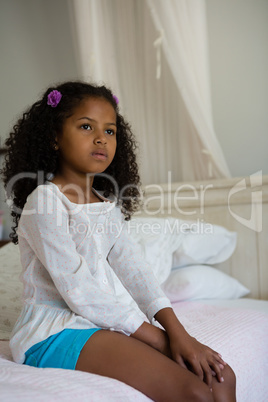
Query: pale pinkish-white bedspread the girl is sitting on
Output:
[[0, 300, 268, 402]]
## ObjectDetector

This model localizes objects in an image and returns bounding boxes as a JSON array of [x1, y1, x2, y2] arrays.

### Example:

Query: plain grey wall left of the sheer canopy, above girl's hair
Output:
[[0, 0, 78, 238]]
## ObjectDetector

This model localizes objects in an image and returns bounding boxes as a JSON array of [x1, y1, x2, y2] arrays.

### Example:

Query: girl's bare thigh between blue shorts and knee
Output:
[[76, 330, 213, 402]]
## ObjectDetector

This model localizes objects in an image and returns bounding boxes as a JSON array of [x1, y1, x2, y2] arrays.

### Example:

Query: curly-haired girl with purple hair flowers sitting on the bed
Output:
[[2, 82, 235, 402]]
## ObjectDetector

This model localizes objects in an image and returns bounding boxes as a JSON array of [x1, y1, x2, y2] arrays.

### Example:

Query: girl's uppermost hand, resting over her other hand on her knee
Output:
[[170, 332, 226, 388]]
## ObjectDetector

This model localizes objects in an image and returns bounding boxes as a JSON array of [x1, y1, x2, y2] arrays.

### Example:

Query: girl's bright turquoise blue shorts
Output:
[[23, 328, 101, 370]]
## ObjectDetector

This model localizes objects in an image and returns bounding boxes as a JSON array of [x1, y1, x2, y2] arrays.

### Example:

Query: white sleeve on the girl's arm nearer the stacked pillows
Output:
[[108, 218, 171, 321]]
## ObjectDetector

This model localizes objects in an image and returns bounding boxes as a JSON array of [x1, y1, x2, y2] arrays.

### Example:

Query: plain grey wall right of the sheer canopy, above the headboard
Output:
[[206, 0, 268, 177]]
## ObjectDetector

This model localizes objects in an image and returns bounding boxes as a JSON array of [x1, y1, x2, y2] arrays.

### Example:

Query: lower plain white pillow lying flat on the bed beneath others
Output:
[[162, 265, 250, 302]]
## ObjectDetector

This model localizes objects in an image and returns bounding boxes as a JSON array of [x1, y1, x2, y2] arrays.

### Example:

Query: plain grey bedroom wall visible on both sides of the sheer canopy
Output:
[[0, 0, 268, 236]]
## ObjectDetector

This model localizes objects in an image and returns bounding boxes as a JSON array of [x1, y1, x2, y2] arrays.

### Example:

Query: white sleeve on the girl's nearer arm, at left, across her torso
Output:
[[18, 186, 144, 335]]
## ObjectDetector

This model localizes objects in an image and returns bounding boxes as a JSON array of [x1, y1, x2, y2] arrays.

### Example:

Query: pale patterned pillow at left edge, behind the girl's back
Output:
[[0, 243, 22, 339]]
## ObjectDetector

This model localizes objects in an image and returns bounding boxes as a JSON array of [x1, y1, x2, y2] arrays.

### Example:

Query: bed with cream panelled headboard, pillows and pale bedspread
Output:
[[0, 175, 268, 402]]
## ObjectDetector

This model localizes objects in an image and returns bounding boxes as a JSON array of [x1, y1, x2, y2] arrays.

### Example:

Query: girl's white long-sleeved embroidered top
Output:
[[10, 182, 171, 363]]
